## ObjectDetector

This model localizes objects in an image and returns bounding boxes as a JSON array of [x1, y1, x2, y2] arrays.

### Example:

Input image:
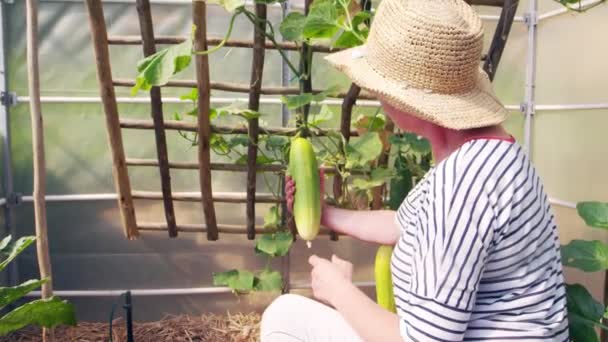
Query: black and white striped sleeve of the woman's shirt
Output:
[[400, 156, 496, 341]]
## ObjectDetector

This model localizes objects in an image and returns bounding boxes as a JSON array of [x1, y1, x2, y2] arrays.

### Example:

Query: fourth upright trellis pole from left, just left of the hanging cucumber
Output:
[[246, 3, 266, 240]]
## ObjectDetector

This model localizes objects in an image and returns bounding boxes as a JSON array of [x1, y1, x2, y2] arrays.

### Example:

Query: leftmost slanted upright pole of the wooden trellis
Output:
[[86, 0, 138, 239]]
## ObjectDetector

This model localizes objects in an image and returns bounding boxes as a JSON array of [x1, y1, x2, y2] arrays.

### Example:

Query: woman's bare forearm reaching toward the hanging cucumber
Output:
[[321, 205, 399, 245]]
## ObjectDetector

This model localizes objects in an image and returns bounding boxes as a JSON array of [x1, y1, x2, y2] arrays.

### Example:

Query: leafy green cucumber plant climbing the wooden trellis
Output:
[[132, 0, 430, 293]]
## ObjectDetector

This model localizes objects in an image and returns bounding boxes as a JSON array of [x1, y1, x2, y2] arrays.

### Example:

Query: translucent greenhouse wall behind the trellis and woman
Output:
[[0, 0, 608, 320]]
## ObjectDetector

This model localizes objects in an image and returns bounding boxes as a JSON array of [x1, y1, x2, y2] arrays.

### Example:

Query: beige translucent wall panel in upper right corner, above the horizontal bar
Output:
[[536, 5, 608, 104]]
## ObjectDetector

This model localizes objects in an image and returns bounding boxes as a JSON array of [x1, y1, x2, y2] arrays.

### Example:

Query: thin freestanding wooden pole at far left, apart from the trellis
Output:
[[25, 0, 54, 341]]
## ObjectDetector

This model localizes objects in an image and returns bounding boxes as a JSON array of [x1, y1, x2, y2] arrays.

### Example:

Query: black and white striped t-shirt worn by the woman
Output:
[[391, 138, 568, 341]]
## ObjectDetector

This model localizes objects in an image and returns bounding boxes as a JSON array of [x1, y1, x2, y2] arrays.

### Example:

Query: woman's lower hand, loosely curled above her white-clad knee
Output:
[[308, 255, 353, 306]]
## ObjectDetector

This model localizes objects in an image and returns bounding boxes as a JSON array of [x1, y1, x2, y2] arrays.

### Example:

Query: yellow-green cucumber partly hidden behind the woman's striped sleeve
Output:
[[374, 246, 397, 312]]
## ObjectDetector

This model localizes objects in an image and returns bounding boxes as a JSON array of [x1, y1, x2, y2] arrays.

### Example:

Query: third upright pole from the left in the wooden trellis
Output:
[[192, 1, 219, 241]]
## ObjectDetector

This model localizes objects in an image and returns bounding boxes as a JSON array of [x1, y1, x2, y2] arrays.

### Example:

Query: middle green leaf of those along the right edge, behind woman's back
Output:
[[561, 240, 608, 272]]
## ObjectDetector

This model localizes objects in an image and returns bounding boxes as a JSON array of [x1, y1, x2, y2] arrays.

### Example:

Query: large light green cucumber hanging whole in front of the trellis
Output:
[[289, 137, 321, 247]]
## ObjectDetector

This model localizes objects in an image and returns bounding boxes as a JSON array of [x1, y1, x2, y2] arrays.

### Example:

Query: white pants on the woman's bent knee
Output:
[[260, 294, 363, 342]]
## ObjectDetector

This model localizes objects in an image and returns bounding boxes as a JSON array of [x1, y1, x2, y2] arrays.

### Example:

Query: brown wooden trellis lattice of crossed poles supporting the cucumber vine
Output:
[[86, 0, 518, 240]]
